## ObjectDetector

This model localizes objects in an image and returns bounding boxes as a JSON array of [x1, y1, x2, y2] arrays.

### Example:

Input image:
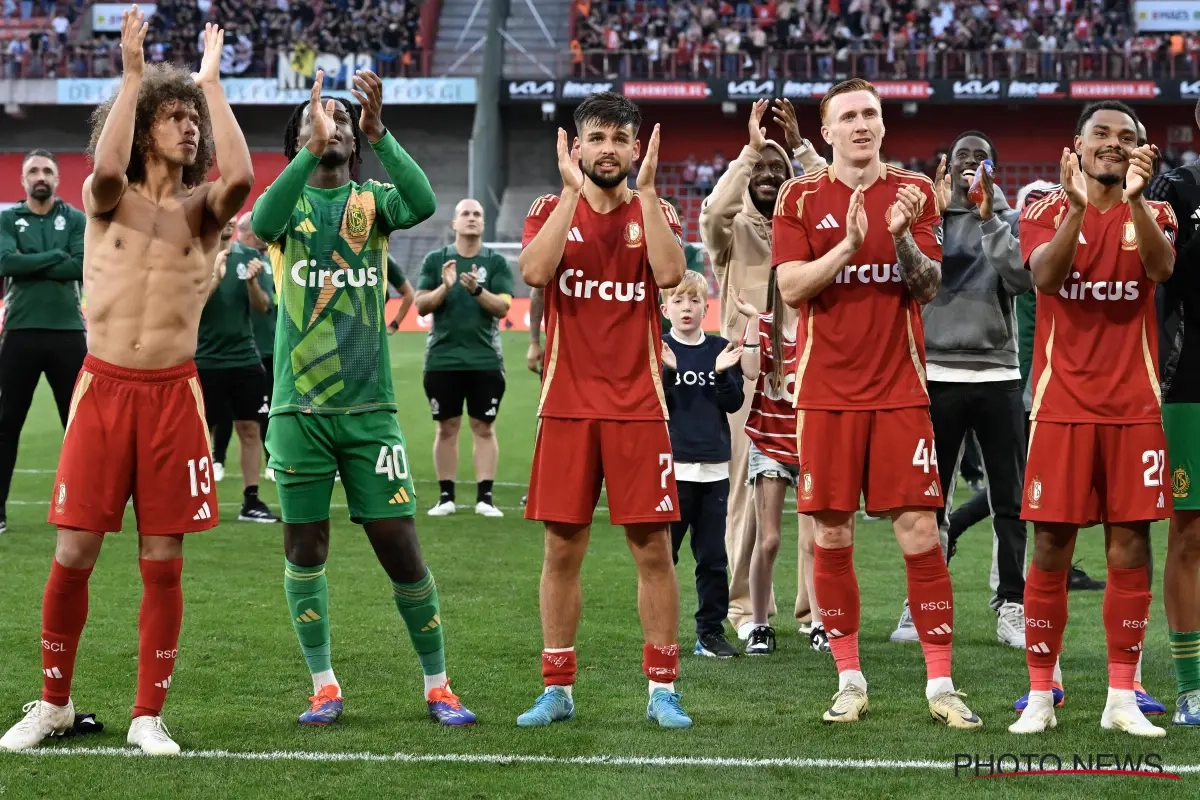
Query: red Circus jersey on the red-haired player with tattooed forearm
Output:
[[770, 164, 942, 411]]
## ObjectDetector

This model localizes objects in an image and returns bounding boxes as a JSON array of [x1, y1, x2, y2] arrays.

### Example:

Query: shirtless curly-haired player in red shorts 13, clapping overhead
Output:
[[0, 6, 254, 756]]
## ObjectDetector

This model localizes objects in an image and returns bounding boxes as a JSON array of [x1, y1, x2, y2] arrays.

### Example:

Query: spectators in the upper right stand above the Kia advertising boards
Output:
[[571, 0, 1200, 80]]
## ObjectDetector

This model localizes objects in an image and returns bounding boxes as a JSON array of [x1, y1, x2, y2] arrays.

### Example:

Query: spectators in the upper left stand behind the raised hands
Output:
[[0, 0, 424, 79]]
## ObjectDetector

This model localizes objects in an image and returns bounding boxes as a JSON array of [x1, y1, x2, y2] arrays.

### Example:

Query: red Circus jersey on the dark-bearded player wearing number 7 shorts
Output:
[[521, 192, 683, 420]]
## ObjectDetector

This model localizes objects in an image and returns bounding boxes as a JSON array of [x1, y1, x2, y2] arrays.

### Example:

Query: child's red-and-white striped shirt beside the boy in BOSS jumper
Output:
[[742, 314, 800, 467]]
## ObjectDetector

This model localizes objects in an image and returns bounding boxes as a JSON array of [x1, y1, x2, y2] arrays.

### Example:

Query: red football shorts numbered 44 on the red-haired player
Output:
[[796, 405, 942, 515]]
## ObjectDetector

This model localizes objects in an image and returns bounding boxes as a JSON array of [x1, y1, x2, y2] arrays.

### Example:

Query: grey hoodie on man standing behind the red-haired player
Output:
[[922, 186, 1033, 369]]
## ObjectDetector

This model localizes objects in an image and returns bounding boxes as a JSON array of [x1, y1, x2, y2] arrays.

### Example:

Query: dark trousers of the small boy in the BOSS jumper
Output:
[[671, 479, 730, 638]]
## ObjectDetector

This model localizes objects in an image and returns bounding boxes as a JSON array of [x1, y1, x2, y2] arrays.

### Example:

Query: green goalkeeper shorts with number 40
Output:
[[266, 410, 416, 524]]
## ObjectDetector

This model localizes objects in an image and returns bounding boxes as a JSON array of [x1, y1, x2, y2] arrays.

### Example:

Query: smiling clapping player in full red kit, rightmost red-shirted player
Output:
[[1009, 101, 1177, 738]]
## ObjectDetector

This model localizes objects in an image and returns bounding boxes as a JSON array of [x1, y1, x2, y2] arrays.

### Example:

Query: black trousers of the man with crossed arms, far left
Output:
[[0, 329, 88, 512]]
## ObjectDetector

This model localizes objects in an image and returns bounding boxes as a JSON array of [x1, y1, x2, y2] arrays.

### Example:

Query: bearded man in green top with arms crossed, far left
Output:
[[0, 150, 88, 534]]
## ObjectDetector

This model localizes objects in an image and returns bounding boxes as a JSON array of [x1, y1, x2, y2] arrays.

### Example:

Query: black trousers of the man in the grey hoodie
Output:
[[929, 380, 1028, 603]]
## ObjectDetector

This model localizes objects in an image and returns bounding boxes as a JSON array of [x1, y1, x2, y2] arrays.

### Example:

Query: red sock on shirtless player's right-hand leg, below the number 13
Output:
[[133, 559, 184, 718]]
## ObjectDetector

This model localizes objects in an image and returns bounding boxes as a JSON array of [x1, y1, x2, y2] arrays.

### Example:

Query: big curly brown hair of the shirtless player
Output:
[[88, 64, 212, 186]]
